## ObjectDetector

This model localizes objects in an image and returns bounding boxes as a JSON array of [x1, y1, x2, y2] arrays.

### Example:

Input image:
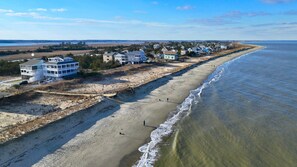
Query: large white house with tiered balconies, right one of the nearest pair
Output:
[[43, 57, 79, 78]]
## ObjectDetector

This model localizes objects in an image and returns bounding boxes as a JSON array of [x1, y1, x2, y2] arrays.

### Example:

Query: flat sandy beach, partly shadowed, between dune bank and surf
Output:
[[2, 47, 261, 166]]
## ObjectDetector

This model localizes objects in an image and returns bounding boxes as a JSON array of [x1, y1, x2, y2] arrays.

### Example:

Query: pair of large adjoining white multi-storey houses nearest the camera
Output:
[[20, 57, 79, 82]]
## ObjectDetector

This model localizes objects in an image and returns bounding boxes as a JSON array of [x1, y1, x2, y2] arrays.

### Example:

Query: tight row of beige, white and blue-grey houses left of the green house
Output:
[[103, 50, 147, 64]]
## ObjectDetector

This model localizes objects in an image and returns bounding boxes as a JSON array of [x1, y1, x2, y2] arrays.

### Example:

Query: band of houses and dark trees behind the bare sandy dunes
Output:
[[0, 42, 234, 84]]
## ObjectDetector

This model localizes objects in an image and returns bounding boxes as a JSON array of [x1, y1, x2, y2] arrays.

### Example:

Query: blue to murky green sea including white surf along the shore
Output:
[[137, 42, 297, 167]]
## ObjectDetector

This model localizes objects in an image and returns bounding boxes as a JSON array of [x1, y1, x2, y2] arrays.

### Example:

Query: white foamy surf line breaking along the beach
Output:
[[134, 58, 238, 167]]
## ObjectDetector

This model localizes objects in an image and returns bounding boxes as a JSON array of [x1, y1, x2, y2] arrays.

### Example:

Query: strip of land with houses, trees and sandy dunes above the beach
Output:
[[0, 42, 259, 167]]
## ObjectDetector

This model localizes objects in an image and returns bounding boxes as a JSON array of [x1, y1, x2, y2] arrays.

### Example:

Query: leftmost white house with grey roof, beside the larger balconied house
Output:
[[20, 59, 44, 80]]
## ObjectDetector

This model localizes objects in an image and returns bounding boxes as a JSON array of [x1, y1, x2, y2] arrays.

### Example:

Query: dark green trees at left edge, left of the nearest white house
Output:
[[0, 60, 20, 76]]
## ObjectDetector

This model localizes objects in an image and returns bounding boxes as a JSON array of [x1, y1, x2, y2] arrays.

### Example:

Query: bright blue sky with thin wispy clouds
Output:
[[0, 0, 297, 40]]
